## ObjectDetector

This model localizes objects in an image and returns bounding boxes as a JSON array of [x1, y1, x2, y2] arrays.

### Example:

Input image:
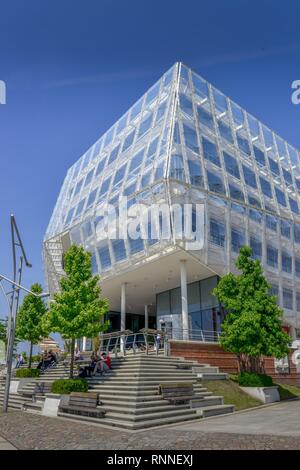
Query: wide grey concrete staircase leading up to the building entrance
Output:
[[0, 353, 234, 430]]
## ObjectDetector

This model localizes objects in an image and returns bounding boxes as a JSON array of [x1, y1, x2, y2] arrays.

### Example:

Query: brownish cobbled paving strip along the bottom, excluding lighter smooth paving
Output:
[[0, 411, 300, 450]]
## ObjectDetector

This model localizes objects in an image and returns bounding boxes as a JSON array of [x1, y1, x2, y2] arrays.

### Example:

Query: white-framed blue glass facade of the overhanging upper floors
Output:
[[44, 63, 300, 328]]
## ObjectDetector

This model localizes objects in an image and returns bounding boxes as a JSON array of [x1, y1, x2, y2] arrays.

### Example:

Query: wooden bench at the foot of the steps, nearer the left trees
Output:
[[59, 392, 105, 418]]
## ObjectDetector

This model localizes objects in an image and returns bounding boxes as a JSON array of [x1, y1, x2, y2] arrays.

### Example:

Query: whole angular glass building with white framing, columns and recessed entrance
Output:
[[44, 63, 300, 337]]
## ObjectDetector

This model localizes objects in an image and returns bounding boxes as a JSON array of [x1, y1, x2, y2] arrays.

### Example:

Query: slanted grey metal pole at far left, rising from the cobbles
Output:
[[3, 256, 23, 413]]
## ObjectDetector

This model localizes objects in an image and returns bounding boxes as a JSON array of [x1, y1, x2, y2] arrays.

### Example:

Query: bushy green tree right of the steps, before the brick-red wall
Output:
[[213, 247, 290, 373]]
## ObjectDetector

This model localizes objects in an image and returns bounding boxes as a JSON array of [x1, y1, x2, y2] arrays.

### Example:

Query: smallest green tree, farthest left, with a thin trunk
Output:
[[16, 283, 48, 368]]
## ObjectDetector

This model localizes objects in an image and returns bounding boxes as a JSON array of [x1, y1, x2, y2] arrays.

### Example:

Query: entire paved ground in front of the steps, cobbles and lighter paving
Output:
[[0, 400, 300, 450]]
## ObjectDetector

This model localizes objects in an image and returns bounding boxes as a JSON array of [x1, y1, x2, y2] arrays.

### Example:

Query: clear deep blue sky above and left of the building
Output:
[[0, 0, 300, 326]]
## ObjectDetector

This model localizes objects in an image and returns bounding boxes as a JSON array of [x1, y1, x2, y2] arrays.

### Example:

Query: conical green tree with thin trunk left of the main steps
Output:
[[47, 245, 109, 378]]
